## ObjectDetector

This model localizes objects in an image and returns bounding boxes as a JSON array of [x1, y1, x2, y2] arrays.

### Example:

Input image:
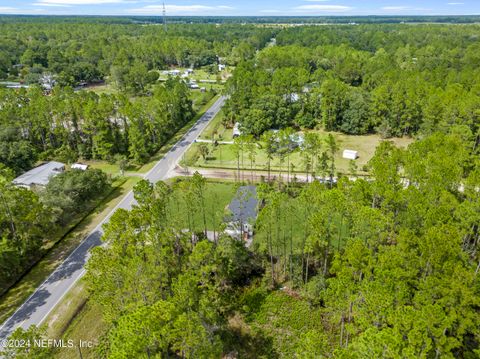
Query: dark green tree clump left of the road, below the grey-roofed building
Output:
[[0, 164, 111, 294]]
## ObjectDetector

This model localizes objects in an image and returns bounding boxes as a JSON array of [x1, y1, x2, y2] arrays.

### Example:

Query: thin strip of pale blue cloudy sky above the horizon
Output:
[[0, 0, 480, 16]]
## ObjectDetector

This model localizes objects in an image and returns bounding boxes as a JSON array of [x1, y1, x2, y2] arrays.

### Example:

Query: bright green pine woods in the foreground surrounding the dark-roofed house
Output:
[[10, 134, 480, 358]]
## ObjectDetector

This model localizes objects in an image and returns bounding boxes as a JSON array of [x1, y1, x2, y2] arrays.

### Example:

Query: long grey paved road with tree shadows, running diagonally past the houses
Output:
[[0, 97, 225, 339]]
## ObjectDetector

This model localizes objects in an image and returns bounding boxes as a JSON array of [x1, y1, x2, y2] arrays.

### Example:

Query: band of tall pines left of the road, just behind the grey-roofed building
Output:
[[0, 79, 194, 173]]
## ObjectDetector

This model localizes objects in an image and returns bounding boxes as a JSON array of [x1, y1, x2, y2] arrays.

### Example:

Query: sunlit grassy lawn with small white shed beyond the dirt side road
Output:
[[183, 130, 413, 174]]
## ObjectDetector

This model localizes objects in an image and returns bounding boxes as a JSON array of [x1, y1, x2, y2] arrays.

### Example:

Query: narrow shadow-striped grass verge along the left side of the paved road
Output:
[[0, 177, 139, 323]]
